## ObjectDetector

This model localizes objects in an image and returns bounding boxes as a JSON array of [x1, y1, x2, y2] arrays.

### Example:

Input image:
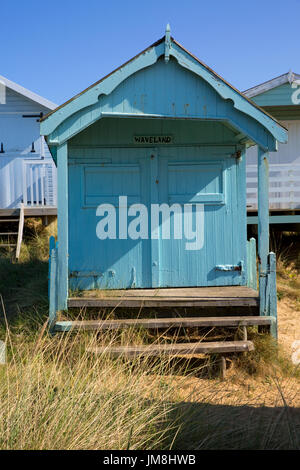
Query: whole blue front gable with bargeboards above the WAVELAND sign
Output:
[[41, 40, 287, 149]]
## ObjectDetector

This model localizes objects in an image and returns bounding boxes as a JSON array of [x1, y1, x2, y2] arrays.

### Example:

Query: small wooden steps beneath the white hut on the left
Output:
[[0, 204, 24, 260]]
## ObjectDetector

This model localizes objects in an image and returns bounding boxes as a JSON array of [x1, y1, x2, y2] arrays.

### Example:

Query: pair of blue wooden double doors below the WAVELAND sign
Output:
[[69, 147, 246, 289]]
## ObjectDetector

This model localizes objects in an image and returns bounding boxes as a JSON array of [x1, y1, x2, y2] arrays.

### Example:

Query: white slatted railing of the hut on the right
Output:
[[246, 164, 300, 210]]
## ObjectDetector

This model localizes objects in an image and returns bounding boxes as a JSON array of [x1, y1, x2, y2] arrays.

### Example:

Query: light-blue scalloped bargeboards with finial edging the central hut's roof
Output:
[[41, 27, 287, 145]]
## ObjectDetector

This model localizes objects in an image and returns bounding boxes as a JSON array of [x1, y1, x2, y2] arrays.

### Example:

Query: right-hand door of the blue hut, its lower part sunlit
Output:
[[159, 148, 245, 287]]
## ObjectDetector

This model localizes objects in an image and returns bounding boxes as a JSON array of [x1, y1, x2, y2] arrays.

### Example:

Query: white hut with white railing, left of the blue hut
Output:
[[0, 76, 56, 217]]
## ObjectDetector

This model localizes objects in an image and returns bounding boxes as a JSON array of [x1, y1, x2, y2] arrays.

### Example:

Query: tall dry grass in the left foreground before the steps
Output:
[[0, 318, 191, 449]]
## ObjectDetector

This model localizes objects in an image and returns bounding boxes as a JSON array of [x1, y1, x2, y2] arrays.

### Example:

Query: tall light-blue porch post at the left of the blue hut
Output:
[[57, 143, 68, 310]]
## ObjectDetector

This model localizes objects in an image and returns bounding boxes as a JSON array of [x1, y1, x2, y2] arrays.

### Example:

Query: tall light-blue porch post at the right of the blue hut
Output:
[[257, 147, 269, 315]]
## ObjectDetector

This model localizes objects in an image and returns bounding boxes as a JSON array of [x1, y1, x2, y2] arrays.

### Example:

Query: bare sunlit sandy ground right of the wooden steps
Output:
[[166, 300, 300, 408]]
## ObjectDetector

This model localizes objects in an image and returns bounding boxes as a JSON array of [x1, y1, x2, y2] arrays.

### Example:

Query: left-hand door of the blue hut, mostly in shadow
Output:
[[69, 149, 151, 289]]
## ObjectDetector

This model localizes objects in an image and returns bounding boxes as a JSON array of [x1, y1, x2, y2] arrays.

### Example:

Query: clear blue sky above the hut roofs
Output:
[[0, 0, 300, 104]]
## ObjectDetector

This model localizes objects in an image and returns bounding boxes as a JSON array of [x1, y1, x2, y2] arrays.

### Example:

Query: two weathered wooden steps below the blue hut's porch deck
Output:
[[54, 316, 275, 378]]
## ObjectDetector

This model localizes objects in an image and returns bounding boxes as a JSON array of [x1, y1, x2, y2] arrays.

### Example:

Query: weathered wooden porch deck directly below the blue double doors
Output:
[[68, 286, 259, 307]]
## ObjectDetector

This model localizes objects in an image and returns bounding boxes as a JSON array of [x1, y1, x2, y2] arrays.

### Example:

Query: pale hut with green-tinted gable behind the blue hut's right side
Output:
[[244, 71, 300, 227]]
